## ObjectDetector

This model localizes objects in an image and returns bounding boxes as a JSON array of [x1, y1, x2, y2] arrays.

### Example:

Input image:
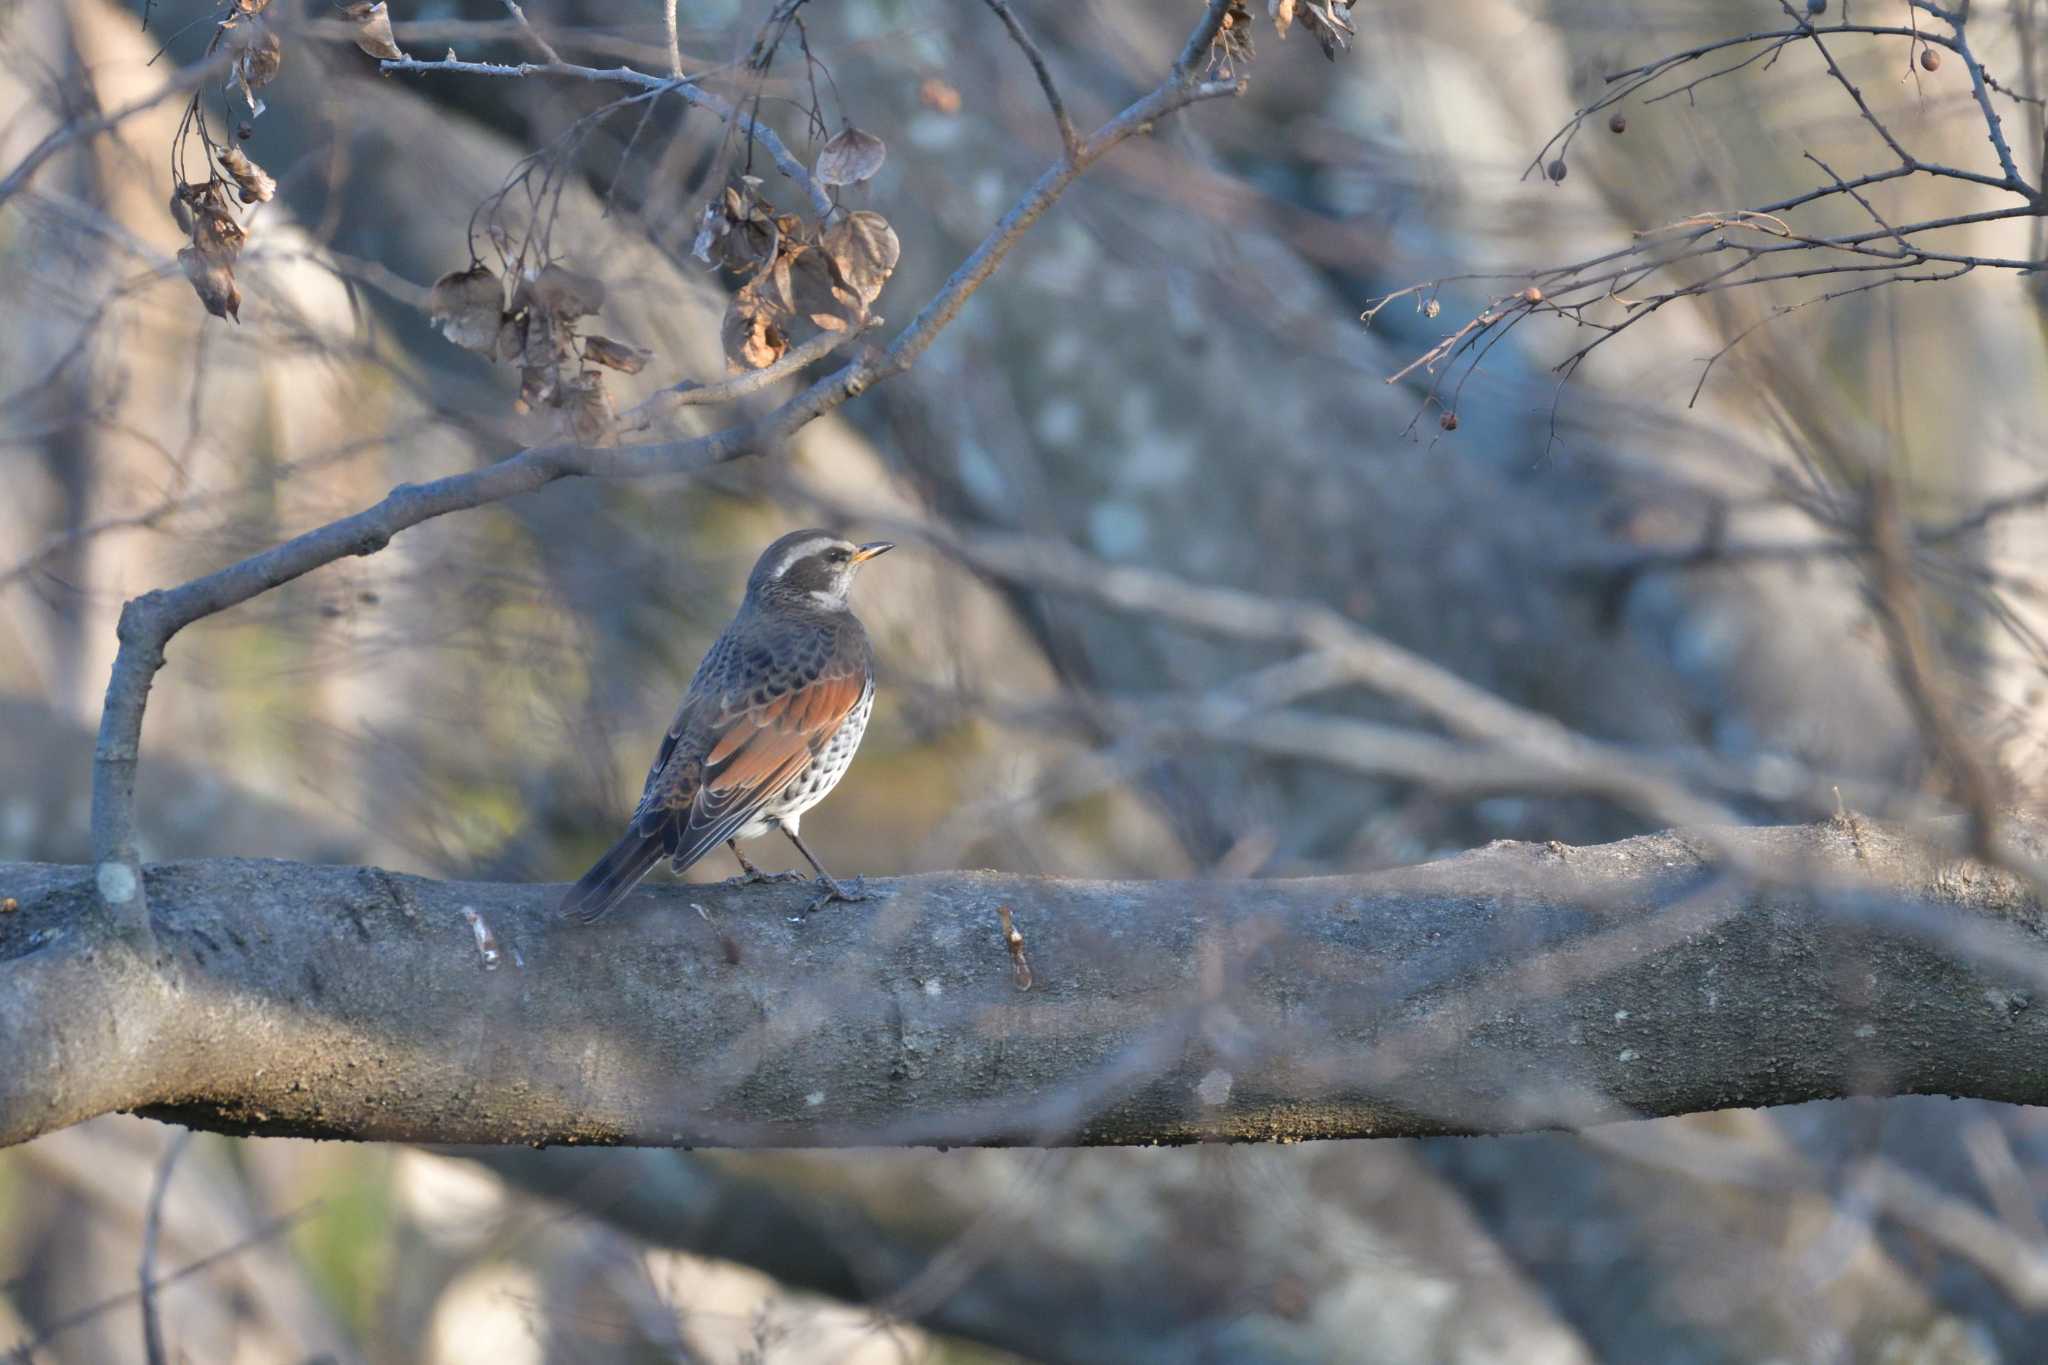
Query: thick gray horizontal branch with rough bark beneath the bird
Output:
[[0, 821, 2048, 1146]]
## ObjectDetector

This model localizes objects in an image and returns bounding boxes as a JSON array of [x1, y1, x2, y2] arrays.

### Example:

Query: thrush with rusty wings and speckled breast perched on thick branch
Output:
[[561, 530, 895, 923]]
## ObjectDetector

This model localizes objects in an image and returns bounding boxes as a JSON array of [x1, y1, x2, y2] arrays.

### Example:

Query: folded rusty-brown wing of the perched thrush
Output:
[[635, 667, 866, 866]]
